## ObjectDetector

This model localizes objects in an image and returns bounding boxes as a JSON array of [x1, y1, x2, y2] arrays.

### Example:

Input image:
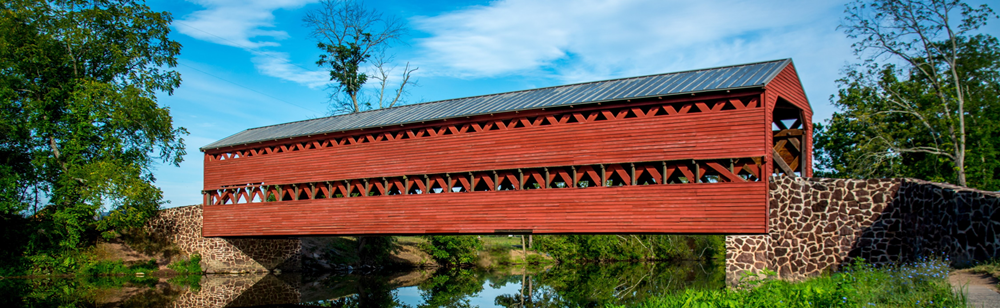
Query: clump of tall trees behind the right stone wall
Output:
[[816, 0, 1000, 188]]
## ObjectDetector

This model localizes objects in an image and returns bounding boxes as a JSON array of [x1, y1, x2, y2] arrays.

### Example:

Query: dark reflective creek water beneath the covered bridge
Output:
[[0, 262, 725, 308]]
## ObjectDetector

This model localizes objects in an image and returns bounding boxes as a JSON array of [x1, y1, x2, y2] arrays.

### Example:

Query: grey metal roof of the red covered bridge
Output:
[[201, 59, 792, 151]]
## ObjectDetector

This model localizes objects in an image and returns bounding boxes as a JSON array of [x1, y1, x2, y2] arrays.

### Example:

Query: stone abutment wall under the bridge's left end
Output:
[[146, 205, 302, 273]]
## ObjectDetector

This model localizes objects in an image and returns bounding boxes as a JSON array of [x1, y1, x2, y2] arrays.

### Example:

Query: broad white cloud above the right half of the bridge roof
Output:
[[413, 0, 835, 77]]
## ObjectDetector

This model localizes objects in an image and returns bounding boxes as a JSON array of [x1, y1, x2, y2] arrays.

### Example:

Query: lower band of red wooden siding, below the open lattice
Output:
[[203, 182, 767, 237]]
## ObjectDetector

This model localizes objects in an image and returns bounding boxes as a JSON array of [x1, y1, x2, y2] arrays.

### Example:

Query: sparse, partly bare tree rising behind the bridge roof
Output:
[[304, 0, 417, 113]]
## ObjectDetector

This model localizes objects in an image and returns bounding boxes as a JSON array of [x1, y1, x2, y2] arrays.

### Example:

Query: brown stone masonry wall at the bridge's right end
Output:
[[726, 177, 1000, 282]]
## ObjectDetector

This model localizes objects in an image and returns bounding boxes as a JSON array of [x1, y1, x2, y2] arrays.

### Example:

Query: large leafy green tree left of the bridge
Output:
[[0, 0, 187, 263]]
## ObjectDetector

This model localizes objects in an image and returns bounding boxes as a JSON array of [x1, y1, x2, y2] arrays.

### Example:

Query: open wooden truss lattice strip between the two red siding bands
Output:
[[203, 157, 763, 205]]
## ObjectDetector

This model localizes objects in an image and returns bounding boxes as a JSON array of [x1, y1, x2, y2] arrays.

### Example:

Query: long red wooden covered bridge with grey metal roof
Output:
[[202, 59, 812, 237]]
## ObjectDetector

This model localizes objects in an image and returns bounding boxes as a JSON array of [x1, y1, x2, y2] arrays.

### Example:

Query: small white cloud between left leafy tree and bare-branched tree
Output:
[[174, 0, 329, 88]]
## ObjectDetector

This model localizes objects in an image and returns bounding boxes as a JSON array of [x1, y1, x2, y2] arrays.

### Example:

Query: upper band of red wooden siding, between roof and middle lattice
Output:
[[205, 94, 769, 190]]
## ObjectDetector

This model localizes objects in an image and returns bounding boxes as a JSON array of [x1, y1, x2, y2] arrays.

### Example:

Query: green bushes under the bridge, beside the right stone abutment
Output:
[[534, 235, 725, 261]]
